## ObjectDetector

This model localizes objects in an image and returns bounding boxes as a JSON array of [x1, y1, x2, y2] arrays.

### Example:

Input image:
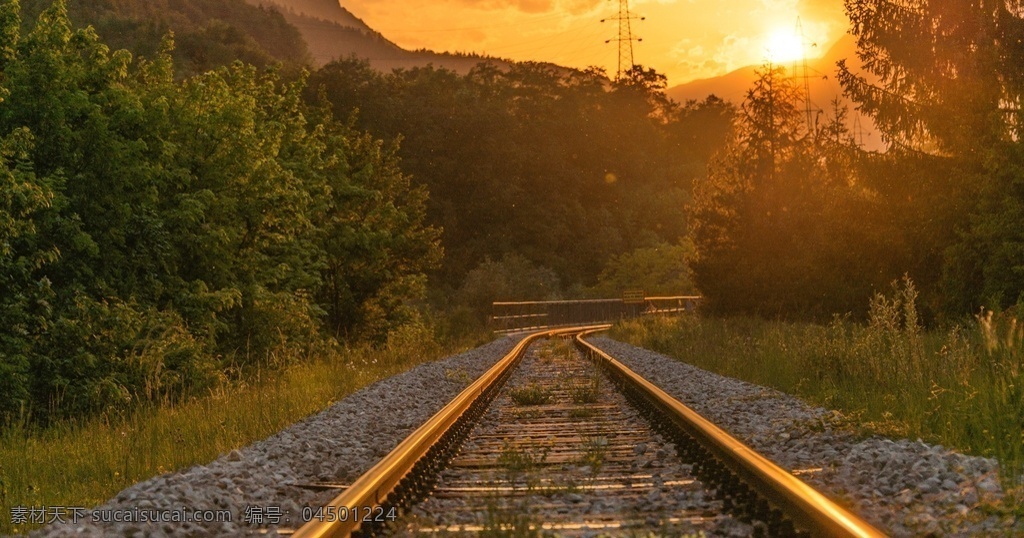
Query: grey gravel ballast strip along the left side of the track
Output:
[[34, 337, 518, 537]]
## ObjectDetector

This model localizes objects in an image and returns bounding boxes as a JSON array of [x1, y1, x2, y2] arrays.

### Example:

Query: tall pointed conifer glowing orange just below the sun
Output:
[[691, 66, 806, 312]]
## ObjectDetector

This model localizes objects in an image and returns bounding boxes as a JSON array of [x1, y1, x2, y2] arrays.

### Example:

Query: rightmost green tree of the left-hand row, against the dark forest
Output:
[[316, 116, 442, 341]]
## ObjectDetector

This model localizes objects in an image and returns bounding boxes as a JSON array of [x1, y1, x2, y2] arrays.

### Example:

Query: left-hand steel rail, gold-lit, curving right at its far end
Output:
[[293, 324, 610, 538]]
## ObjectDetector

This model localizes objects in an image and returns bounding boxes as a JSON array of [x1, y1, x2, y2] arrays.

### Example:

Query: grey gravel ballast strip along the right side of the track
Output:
[[591, 338, 1024, 536]]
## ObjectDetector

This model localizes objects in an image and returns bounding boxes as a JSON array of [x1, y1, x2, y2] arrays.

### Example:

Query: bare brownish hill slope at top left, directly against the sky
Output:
[[247, 0, 505, 74]]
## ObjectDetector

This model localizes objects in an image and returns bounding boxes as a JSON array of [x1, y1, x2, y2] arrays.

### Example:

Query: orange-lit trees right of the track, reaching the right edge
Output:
[[690, 0, 1024, 320]]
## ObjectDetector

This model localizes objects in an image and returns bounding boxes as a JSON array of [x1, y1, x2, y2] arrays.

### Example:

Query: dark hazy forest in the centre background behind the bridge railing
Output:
[[307, 59, 733, 298]]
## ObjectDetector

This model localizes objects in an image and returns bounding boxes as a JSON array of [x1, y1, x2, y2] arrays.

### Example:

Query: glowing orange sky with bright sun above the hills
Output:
[[341, 0, 847, 85]]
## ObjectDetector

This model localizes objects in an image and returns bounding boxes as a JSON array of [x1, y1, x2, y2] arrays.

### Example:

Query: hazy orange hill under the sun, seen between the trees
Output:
[[666, 35, 884, 150]]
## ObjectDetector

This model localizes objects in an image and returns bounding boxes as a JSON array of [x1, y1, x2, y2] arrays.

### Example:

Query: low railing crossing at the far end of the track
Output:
[[490, 291, 700, 333]]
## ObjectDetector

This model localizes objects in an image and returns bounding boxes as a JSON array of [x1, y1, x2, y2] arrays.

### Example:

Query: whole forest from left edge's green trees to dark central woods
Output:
[[0, 0, 733, 421]]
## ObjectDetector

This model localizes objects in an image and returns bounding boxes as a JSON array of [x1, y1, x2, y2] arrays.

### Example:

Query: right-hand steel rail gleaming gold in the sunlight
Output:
[[577, 329, 886, 538]]
